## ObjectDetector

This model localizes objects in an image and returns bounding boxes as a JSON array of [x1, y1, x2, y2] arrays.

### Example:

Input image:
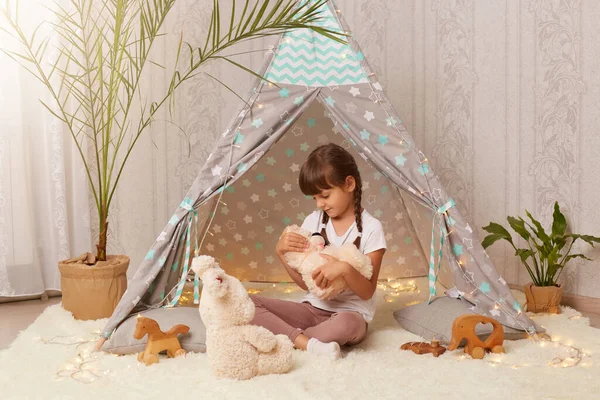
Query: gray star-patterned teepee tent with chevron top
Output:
[[103, 1, 536, 337]]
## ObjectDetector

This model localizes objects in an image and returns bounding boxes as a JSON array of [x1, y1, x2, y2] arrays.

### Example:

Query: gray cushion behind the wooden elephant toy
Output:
[[394, 297, 527, 344]]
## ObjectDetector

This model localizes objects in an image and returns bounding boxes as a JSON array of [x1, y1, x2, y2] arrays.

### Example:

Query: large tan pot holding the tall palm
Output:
[[58, 255, 129, 320]]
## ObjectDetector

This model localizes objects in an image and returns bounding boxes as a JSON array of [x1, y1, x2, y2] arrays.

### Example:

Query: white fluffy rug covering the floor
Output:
[[0, 282, 600, 400]]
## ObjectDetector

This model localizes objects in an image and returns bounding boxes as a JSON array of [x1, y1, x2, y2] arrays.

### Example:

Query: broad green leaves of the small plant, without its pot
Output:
[[482, 202, 600, 286]]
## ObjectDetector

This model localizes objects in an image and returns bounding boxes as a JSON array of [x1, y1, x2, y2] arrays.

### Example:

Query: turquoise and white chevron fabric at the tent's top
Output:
[[265, 0, 367, 86]]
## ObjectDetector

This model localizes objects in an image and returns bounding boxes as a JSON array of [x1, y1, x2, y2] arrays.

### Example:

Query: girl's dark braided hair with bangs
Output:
[[298, 143, 362, 238]]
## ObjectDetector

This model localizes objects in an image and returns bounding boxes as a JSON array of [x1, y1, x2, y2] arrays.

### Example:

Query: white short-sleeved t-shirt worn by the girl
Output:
[[301, 209, 386, 322]]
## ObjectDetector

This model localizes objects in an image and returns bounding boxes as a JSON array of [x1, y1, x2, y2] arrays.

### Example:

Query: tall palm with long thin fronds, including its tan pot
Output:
[[1, 0, 344, 319]]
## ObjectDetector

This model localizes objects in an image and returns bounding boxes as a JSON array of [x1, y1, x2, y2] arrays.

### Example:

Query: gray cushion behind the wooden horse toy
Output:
[[102, 307, 206, 354]]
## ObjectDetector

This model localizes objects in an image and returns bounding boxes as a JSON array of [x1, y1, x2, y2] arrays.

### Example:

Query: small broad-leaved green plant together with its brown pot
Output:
[[482, 202, 600, 314]]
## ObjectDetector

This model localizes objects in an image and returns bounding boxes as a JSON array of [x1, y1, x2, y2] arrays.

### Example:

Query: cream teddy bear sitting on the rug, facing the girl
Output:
[[192, 256, 293, 379]]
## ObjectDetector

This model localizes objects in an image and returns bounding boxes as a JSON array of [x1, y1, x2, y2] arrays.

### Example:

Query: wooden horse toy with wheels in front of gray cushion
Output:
[[133, 316, 190, 365]]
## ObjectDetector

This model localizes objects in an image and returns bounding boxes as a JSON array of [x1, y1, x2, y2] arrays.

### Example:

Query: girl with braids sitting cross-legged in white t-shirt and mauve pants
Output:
[[251, 143, 386, 358]]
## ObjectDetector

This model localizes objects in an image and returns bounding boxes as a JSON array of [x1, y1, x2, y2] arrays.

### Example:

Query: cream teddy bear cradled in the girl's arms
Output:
[[284, 225, 373, 300]]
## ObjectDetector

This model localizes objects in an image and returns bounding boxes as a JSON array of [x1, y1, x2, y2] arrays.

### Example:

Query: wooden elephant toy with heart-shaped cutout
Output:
[[448, 314, 504, 359]]
